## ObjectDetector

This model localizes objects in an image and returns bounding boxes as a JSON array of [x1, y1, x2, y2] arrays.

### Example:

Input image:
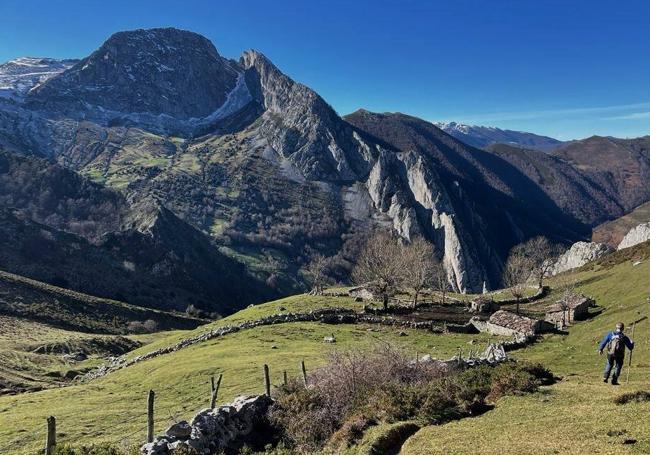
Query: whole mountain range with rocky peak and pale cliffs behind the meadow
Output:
[[0, 29, 650, 313]]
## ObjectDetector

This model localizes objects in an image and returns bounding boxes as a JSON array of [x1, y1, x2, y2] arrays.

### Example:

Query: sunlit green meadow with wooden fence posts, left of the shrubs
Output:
[[0, 296, 493, 453]]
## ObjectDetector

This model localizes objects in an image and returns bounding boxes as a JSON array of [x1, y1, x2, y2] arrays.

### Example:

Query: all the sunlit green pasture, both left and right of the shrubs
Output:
[[0, 244, 650, 454]]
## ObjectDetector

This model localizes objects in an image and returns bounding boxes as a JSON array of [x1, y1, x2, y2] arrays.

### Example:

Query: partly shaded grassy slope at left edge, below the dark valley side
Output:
[[0, 271, 202, 395]]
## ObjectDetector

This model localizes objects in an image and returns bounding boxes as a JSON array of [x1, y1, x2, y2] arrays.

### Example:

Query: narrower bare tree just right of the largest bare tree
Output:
[[403, 237, 440, 308]]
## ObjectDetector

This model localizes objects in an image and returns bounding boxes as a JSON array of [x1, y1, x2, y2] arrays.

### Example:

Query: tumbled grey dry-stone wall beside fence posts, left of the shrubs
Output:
[[141, 395, 273, 455]]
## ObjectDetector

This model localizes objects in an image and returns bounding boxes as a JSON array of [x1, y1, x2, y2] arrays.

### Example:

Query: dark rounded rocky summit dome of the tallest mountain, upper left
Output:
[[29, 28, 239, 119]]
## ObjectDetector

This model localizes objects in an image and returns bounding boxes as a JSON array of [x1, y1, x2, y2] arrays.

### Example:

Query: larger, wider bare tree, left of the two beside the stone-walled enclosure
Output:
[[352, 232, 404, 310]]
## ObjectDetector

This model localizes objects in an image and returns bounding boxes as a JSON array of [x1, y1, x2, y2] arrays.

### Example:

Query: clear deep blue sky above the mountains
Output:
[[0, 0, 650, 139]]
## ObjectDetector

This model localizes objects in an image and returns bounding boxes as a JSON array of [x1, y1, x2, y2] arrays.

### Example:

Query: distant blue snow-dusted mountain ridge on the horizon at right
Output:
[[434, 122, 564, 152]]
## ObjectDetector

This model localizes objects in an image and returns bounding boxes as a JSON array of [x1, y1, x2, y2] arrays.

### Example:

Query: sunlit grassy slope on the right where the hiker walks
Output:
[[403, 244, 650, 454]]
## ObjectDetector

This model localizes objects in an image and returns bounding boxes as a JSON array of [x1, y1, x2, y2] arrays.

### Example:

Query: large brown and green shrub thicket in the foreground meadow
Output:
[[270, 345, 552, 452]]
